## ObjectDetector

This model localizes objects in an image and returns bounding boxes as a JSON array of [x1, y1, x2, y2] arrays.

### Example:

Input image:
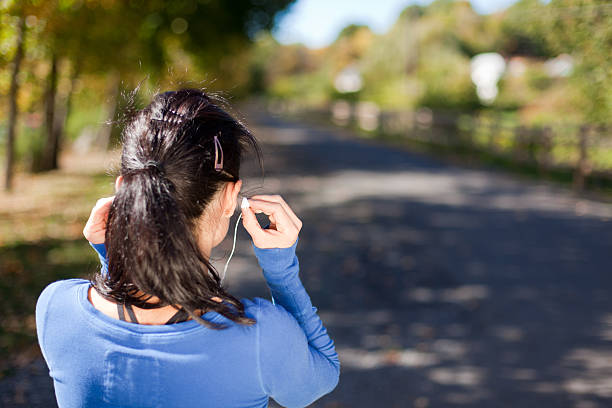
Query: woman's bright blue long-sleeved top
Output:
[[36, 237, 340, 408]]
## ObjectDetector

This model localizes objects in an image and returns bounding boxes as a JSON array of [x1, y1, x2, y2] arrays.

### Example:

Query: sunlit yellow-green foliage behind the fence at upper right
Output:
[[256, 0, 612, 124]]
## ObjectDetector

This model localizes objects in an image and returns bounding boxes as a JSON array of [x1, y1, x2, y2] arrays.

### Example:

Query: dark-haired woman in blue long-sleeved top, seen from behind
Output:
[[36, 89, 340, 408]]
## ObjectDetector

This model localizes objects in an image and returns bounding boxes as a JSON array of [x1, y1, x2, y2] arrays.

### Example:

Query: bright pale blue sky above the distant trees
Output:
[[273, 0, 516, 48]]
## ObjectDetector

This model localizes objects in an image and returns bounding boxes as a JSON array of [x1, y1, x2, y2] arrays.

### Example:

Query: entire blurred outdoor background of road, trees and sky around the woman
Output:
[[0, 0, 612, 408]]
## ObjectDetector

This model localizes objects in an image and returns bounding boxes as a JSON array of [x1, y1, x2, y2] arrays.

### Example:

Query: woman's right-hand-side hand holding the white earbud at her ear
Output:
[[242, 195, 302, 248]]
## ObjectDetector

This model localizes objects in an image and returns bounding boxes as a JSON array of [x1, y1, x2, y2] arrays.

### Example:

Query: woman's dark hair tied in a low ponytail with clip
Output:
[[92, 89, 261, 328]]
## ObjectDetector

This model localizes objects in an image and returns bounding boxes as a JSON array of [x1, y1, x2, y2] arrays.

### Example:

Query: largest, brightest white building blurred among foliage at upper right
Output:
[[470, 52, 506, 104]]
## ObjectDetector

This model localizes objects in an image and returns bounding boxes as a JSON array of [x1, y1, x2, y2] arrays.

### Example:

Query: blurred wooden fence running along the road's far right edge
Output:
[[274, 101, 612, 189]]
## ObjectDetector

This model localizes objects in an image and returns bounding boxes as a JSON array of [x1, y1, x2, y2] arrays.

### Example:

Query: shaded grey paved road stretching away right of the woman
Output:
[[0, 112, 612, 408]]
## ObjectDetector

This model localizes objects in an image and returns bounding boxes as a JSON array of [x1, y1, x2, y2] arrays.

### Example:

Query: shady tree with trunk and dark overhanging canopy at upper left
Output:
[[4, 0, 294, 174]]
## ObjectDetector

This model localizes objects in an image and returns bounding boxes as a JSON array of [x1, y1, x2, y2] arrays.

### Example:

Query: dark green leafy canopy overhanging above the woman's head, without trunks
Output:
[[0, 0, 295, 99]]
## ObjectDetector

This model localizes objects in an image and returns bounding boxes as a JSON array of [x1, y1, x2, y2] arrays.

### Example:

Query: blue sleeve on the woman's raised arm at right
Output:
[[253, 240, 340, 407]]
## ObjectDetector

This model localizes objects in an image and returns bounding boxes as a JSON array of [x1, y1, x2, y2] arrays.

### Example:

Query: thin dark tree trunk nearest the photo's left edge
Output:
[[4, 16, 25, 191]]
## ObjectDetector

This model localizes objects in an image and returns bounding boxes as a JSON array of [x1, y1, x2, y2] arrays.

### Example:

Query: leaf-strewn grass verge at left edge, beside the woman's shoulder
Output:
[[0, 148, 115, 377]]
